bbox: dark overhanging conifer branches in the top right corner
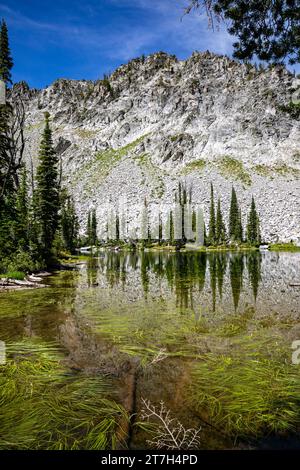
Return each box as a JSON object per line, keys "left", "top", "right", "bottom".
{"left": 186, "top": 0, "right": 300, "bottom": 64}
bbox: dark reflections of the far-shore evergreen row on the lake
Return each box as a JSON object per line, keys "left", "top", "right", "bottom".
{"left": 87, "top": 251, "right": 261, "bottom": 312}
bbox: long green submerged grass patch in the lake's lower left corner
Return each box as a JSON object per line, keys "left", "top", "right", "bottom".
{"left": 0, "top": 340, "right": 128, "bottom": 449}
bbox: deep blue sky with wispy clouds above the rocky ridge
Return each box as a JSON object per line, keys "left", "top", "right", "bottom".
{"left": 0, "top": 0, "right": 298, "bottom": 88}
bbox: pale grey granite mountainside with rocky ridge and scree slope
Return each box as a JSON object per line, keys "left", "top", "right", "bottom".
{"left": 13, "top": 52, "right": 300, "bottom": 242}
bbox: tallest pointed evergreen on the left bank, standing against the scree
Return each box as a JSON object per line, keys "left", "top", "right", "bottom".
{"left": 34, "top": 113, "right": 60, "bottom": 264}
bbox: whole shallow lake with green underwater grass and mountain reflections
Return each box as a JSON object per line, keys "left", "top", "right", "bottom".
{"left": 0, "top": 252, "right": 300, "bottom": 450}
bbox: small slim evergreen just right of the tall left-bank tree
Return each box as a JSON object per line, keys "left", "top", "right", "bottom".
{"left": 61, "top": 191, "right": 79, "bottom": 253}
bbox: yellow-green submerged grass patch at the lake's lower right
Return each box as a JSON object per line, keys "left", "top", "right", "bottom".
{"left": 189, "top": 342, "right": 300, "bottom": 438}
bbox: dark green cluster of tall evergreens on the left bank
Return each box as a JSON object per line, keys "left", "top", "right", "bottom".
{"left": 0, "top": 21, "right": 77, "bottom": 272}
